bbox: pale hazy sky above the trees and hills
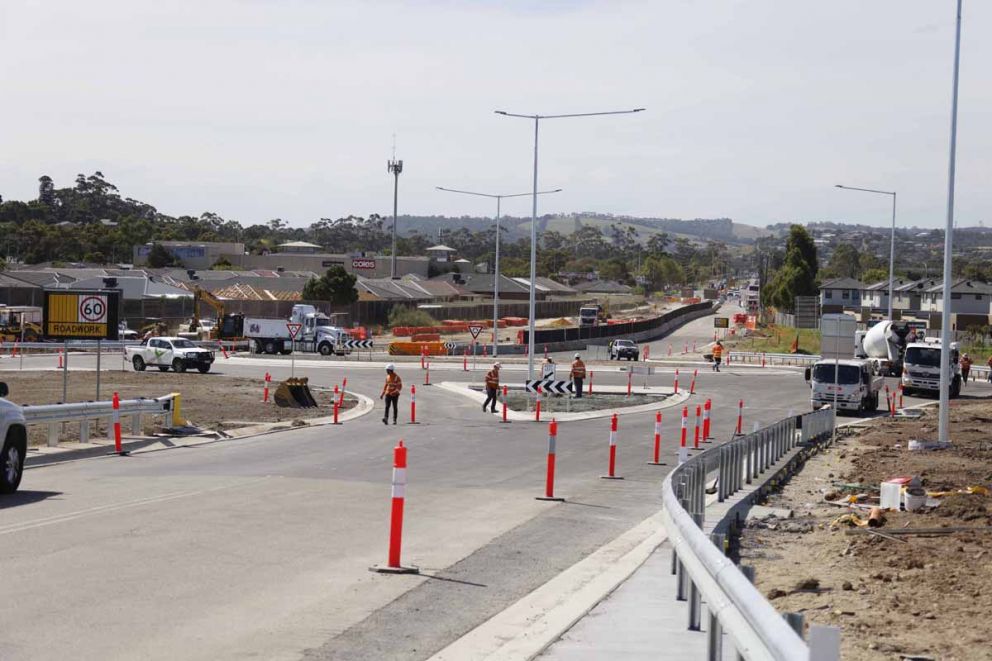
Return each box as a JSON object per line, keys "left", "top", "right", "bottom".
{"left": 0, "top": 0, "right": 992, "bottom": 226}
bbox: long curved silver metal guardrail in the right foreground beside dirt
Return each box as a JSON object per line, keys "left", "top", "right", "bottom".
{"left": 662, "top": 409, "right": 839, "bottom": 661}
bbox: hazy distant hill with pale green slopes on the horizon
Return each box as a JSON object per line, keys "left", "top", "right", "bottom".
{"left": 396, "top": 212, "right": 771, "bottom": 245}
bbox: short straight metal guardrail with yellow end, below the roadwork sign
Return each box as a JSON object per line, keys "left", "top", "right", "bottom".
{"left": 21, "top": 393, "right": 183, "bottom": 447}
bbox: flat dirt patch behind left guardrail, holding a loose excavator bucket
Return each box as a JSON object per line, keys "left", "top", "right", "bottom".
{"left": 0, "top": 370, "right": 357, "bottom": 445}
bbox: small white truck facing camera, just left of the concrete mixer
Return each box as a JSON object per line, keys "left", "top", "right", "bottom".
{"left": 806, "top": 359, "right": 885, "bottom": 413}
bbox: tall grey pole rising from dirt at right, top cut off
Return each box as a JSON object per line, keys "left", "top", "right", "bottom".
{"left": 937, "top": 0, "right": 961, "bottom": 443}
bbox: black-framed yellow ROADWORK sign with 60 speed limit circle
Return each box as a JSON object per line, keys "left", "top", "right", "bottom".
{"left": 42, "top": 289, "right": 120, "bottom": 340}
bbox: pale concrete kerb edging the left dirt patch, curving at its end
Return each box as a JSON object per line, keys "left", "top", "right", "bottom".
{"left": 24, "top": 392, "right": 375, "bottom": 469}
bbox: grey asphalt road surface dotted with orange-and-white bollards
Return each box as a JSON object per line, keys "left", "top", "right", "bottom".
{"left": 0, "top": 310, "right": 984, "bottom": 659}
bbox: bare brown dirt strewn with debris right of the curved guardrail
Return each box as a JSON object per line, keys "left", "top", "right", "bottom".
{"left": 740, "top": 402, "right": 992, "bottom": 661}
